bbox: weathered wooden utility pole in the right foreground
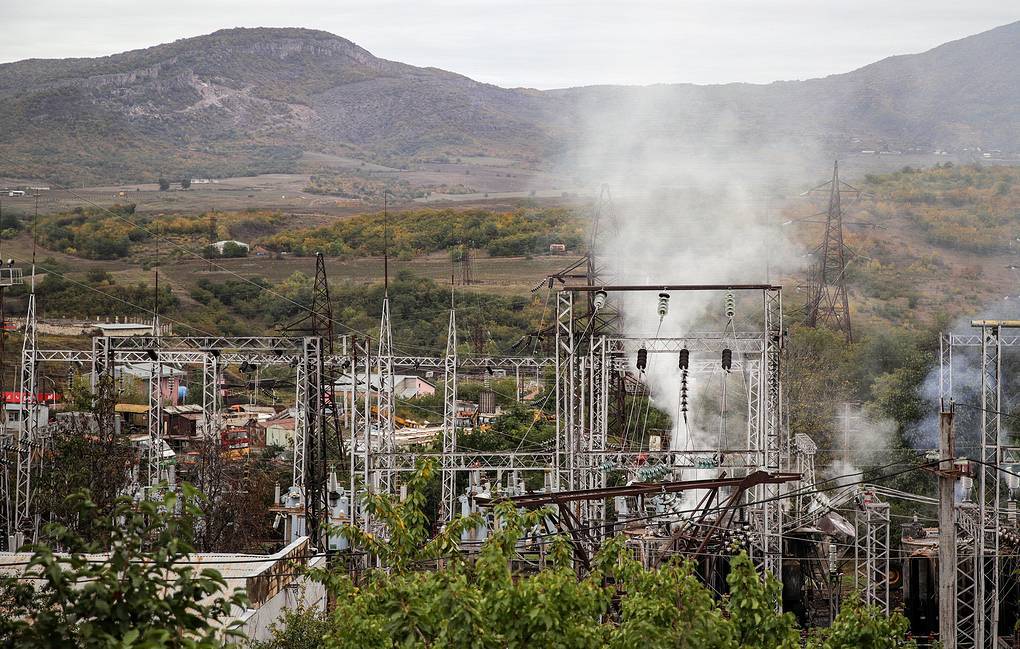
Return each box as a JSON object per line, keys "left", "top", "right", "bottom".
{"left": 938, "top": 403, "right": 957, "bottom": 649}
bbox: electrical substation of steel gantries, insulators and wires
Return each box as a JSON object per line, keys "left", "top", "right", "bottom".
{"left": 0, "top": 178, "right": 1020, "bottom": 649}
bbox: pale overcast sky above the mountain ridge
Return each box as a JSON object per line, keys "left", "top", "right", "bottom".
{"left": 0, "top": 0, "right": 1020, "bottom": 88}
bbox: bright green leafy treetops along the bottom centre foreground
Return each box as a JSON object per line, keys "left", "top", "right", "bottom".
{"left": 248, "top": 462, "right": 912, "bottom": 649}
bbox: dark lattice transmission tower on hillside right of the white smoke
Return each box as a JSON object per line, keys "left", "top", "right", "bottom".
{"left": 808, "top": 161, "right": 860, "bottom": 341}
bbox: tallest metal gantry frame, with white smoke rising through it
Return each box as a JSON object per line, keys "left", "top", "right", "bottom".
{"left": 555, "top": 285, "right": 786, "bottom": 576}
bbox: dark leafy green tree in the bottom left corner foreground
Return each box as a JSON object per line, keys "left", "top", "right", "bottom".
{"left": 0, "top": 484, "right": 246, "bottom": 649}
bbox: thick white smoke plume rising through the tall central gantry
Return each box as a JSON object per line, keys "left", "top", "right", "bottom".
{"left": 550, "top": 89, "right": 830, "bottom": 449}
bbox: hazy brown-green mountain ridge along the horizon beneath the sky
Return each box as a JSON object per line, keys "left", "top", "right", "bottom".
{"left": 0, "top": 21, "right": 1020, "bottom": 182}
